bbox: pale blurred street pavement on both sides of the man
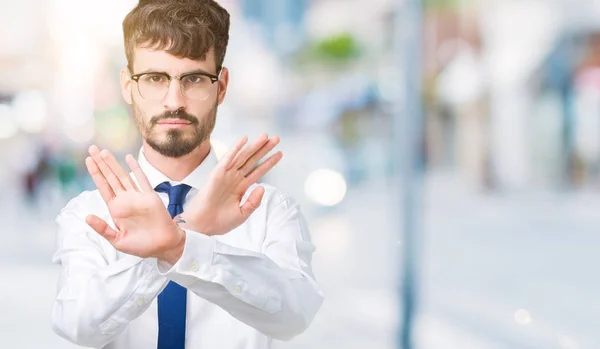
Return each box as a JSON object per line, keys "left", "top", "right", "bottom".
{"left": 0, "top": 168, "right": 600, "bottom": 349}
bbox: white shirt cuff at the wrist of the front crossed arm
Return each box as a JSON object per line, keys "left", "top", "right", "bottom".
{"left": 157, "top": 229, "right": 216, "bottom": 287}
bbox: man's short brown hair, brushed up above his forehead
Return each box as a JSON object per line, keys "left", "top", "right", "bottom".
{"left": 123, "top": 0, "right": 229, "bottom": 73}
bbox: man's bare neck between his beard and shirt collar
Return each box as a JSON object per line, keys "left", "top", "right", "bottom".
{"left": 143, "top": 139, "right": 210, "bottom": 182}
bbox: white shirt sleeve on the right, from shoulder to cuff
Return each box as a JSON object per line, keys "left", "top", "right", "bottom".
{"left": 158, "top": 189, "right": 323, "bottom": 340}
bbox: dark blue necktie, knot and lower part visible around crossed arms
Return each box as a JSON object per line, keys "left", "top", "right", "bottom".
{"left": 154, "top": 182, "right": 192, "bottom": 349}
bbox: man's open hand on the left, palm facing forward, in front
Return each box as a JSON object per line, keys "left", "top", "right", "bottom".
{"left": 85, "top": 146, "right": 185, "bottom": 264}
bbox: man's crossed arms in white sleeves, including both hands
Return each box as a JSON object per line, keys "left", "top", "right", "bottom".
{"left": 52, "top": 134, "right": 322, "bottom": 346}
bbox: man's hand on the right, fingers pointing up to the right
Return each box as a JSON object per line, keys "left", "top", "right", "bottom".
{"left": 178, "top": 134, "right": 283, "bottom": 235}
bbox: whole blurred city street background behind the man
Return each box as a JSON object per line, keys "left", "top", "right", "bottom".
{"left": 0, "top": 0, "right": 600, "bottom": 349}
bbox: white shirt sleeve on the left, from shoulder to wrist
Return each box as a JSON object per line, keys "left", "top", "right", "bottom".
{"left": 52, "top": 192, "right": 168, "bottom": 347}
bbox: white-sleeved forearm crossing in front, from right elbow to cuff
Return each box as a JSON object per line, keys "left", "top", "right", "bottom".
{"left": 159, "top": 231, "right": 323, "bottom": 340}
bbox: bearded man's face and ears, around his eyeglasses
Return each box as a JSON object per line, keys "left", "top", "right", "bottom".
{"left": 121, "top": 48, "right": 228, "bottom": 158}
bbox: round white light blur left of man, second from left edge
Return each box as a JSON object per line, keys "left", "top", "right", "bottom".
{"left": 12, "top": 91, "right": 48, "bottom": 133}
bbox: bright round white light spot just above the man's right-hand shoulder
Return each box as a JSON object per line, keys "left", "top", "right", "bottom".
{"left": 304, "top": 169, "right": 347, "bottom": 206}
